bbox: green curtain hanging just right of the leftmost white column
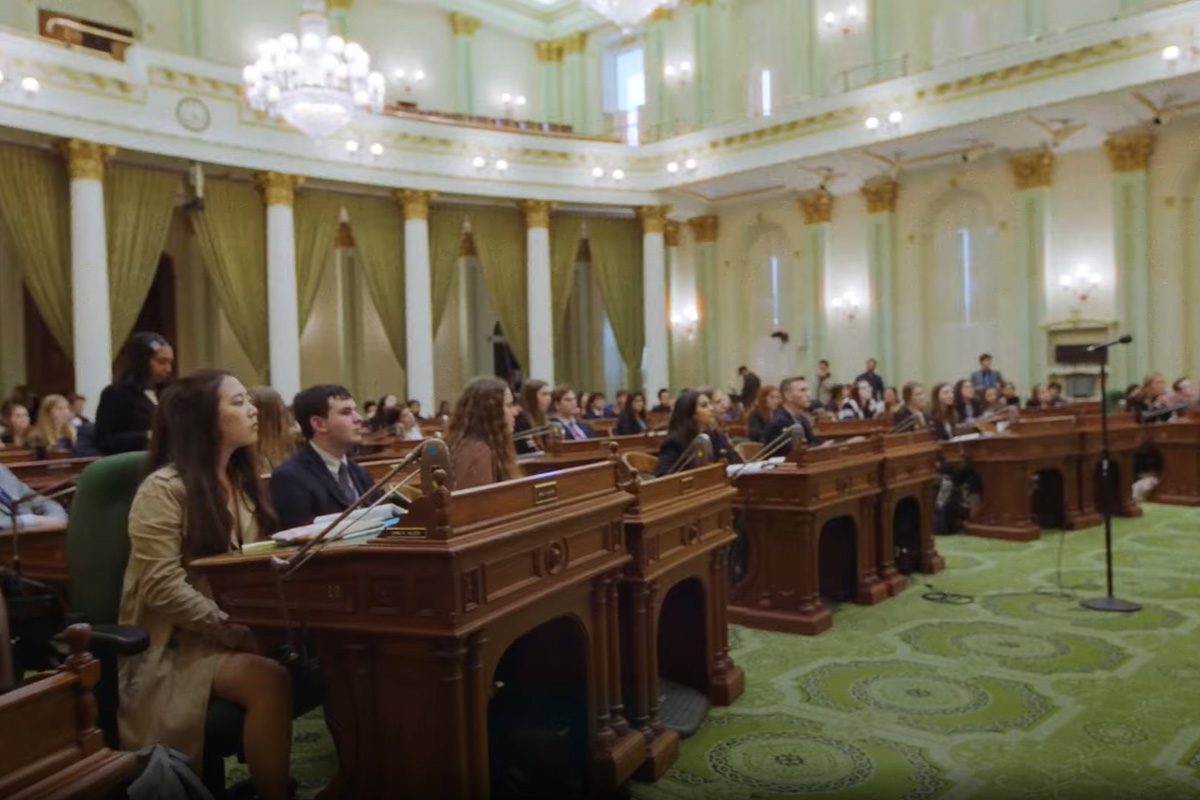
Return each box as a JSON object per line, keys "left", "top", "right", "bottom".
{"left": 104, "top": 164, "right": 181, "bottom": 353}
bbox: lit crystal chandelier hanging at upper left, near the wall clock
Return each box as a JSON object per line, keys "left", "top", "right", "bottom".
{"left": 241, "top": 0, "right": 384, "bottom": 138}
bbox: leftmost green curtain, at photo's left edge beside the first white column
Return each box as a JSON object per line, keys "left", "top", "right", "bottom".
{"left": 0, "top": 145, "right": 74, "bottom": 356}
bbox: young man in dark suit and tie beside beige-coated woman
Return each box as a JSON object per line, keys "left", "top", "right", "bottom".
{"left": 269, "top": 384, "right": 372, "bottom": 529}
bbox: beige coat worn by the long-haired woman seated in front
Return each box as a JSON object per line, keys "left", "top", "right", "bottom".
{"left": 118, "top": 467, "right": 258, "bottom": 772}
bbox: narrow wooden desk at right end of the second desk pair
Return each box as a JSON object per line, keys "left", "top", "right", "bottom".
{"left": 875, "top": 431, "right": 946, "bottom": 595}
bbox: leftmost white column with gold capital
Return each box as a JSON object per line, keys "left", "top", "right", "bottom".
{"left": 62, "top": 139, "right": 116, "bottom": 413}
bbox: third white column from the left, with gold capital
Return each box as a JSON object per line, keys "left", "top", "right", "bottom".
{"left": 396, "top": 190, "right": 437, "bottom": 414}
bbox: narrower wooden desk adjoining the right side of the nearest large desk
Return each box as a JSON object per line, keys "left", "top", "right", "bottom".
{"left": 620, "top": 462, "right": 745, "bottom": 781}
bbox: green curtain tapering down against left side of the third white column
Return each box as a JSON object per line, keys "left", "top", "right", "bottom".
{"left": 344, "top": 197, "right": 408, "bottom": 372}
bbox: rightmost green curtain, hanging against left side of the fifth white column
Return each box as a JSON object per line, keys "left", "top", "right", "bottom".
{"left": 588, "top": 217, "right": 646, "bottom": 386}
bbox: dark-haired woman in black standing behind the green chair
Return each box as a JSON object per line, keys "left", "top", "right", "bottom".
{"left": 94, "top": 332, "right": 175, "bottom": 456}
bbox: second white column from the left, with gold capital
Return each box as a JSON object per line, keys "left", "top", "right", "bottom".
{"left": 254, "top": 173, "right": 304, "bottom": 397}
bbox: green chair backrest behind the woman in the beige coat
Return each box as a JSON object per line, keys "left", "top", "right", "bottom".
{"left": 67, "top": 452, "right": 146, "bottom": 625}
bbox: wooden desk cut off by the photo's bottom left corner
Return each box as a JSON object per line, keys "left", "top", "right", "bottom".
{"left": 0, "top": 623, "right": 137, "bottom": 800}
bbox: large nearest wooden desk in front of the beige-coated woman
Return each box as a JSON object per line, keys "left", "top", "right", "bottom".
{"left": 192, "top": 461, "right": 647, "bottom": 800}
